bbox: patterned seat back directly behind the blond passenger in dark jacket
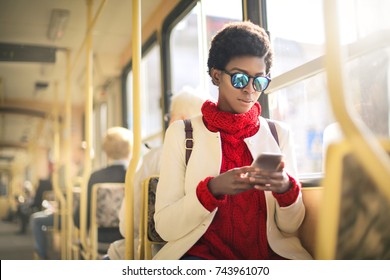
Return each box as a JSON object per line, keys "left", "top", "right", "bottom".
{"left": 88, "top": 183, "right": 125, "bottom": 260}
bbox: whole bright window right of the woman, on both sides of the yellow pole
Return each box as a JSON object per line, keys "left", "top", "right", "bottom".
{"left": 267, "top": 0, "right": 390, "bottom": 176}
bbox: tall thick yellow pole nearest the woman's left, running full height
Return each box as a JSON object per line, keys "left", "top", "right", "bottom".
{"left": 125, "top": 0, "right": 142, "bottom": 260}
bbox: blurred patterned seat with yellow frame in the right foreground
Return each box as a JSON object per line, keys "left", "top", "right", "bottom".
{"left": 317, "top": 139, "right": 390, "bottom": 260}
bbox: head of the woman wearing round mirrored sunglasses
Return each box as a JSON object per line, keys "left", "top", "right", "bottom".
{"left": 207, "top": 21, "right": 273, "bottom": 114}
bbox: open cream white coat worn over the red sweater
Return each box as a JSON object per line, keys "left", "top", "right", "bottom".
{"left": 154, "top": 116, "right": 311, "bottom": 260}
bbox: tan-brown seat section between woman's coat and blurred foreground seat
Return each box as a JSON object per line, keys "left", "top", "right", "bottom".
{"left": 298, "top": 187, "right": 323, "bottom": 258}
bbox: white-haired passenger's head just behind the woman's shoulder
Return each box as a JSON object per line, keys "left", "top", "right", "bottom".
{"left": 170, "top": 87, "right": 205, "bottom": 122}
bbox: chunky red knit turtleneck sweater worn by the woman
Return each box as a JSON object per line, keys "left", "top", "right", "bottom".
{"left": 186, "top": 101, "right": 300, "bottom": 260}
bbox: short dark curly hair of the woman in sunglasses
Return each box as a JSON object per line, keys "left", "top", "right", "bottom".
{"left": 207, "top": 21, "right": 273, "bottom": 77}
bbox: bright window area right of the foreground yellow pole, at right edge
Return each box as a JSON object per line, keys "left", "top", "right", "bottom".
{"left": 339, "top": 0, "right": 390, "bottom": 138}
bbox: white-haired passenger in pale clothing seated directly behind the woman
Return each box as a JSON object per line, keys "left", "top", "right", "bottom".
{"left": 106, "top": 87, "right": 205, "bottom": 260}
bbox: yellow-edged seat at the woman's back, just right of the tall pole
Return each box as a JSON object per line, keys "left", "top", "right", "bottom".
{"left": 140, "top": 176, "right": 165, "bottom": 260}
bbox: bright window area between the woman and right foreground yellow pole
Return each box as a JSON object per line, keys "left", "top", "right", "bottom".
{"left": 267, "top": 0, "right": 328, "bottom": 175}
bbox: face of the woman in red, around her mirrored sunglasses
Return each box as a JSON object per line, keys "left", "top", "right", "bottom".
{"left": 211, "top": 56, "right": 266, "bottom": 114}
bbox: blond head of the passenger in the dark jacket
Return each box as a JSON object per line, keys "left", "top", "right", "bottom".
{"left": 103, "top": 126, "right": 133, "bottom": 160}
